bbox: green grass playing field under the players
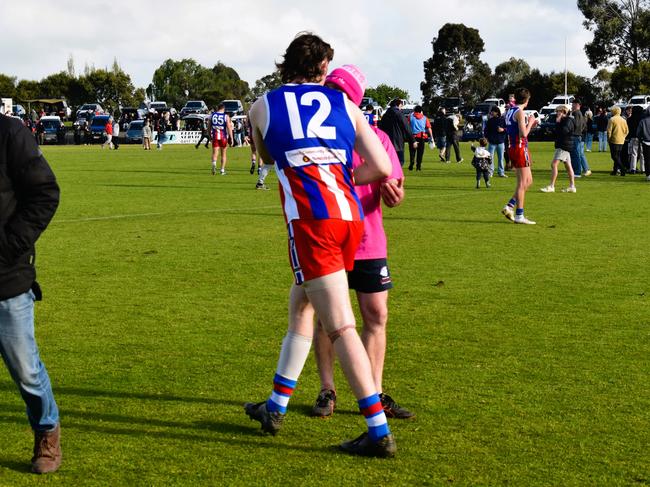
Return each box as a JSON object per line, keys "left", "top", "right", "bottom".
{"left": 0, "top": 143, "right": 650, "bottom": 486}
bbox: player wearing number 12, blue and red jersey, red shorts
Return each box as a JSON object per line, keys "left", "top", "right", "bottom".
{"left": 245, "top": 34, "right": 396, "bottom": 457}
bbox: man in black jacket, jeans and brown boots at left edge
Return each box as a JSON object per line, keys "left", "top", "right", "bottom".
{"left": 0, "top": 116, "right": 61, "bottom": 473}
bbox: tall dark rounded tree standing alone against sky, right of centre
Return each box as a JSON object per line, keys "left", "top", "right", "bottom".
{"left": 420, "top": 24, "right": 491, "bottom": 113}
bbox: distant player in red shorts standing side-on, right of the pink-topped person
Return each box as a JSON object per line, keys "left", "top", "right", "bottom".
{"left": 501, "top": 88, "right": 537, "bottom": 225}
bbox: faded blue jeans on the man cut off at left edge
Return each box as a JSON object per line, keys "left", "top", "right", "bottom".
{"left": 0, "top": 291, "right": 59, "bottom": 431}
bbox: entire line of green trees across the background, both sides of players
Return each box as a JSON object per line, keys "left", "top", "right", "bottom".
{"left": 0, "top": 0, "right": 650, "bottom": 113}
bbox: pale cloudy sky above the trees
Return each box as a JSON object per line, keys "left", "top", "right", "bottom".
{"left": 0, "top": 0, "right": 595, "bottom": 101}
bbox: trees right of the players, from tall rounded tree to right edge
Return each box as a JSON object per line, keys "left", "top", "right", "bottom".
{"left": 420, "top": 0, "right": 650, "bottom": 112}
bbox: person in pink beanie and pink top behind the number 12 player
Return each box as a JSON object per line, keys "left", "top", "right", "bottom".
{"left": 312, "top": 65, "right": 414, "bottom": 419}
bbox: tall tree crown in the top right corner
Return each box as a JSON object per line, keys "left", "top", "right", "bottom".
{"left": 578, "top": 0, "right": 650, "bottom": 69}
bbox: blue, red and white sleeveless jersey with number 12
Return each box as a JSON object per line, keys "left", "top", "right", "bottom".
{"left": 262, "top": 83, "right": 363, "bottom": 223}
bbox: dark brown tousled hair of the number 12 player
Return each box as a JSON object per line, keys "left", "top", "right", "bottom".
{"left": 275, "top": 32, "right": 334, "bottom": 83}
